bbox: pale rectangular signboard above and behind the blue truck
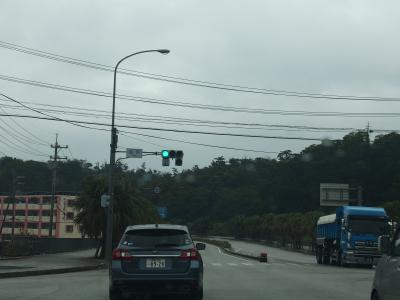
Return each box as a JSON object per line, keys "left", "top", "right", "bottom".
{"left": 319, "top": 183, "right": 350, "bottom": 206}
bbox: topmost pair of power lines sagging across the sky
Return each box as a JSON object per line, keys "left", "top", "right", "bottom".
{"left": 0, "top": 41, "right": 400, "bottom": 101}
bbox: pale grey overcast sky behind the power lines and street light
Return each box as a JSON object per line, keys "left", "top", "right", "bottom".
{"left": 0, "top": 0, "right": 400, "bottom": 171}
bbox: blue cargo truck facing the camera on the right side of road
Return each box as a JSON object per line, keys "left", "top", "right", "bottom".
{"left": 315, "top": 206, "right": 389, "bottom": 267}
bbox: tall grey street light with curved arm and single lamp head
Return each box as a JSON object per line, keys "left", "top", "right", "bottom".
{"left": 105, "top": 49, "right": 170, "bottom": 262}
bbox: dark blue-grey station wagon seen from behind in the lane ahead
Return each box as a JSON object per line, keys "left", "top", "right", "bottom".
{"left": 110, "top": 224, "right": 206, "bottom": 300}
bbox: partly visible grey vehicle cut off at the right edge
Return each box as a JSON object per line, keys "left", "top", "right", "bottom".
{"left": 371, "top": 228, "right": 400, "bottom": 300}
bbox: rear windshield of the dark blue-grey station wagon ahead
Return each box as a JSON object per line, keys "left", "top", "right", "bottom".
{"left": 121, "top": 229, "right": 192, "bottom": 248}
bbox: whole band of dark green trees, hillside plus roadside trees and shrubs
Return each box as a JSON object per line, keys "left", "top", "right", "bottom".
{"left": 0, "top": 131, "right": 400, "bottom": 251}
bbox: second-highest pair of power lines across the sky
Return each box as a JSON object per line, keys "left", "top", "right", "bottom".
{"left": 0, "top": 75, "right": 400, "bottom": 117}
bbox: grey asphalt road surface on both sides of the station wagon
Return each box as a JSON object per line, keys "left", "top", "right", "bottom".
{"left": 0, "top": 242, "right": 374, "bottom": 300}
